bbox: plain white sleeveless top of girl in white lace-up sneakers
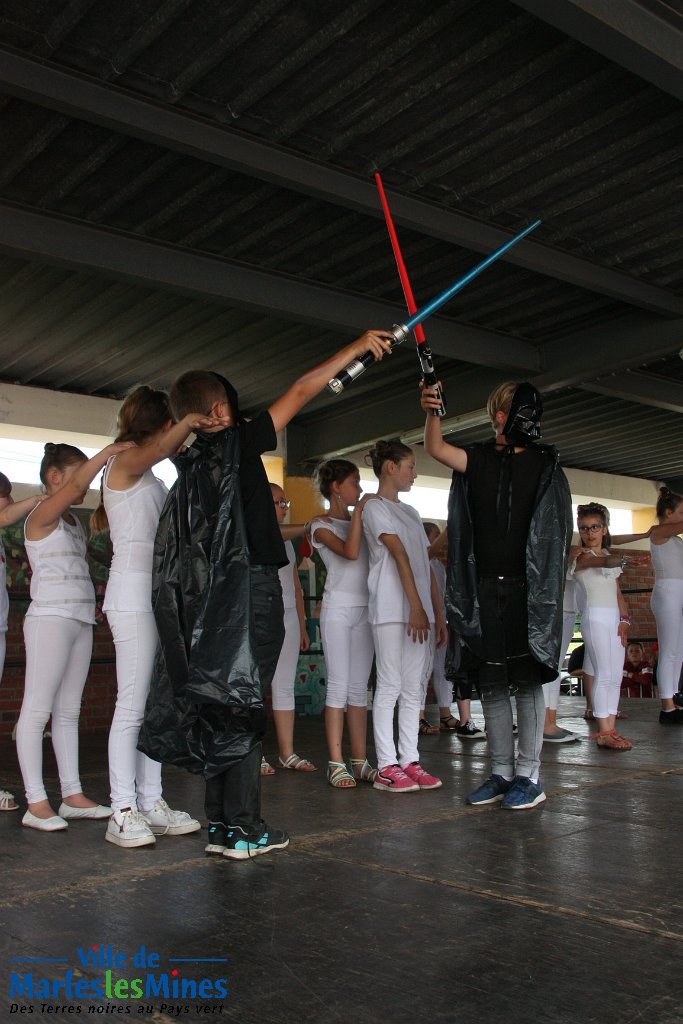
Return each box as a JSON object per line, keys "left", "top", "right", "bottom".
{"left": 102, "top": 456, "right": 168, "bottom": 611}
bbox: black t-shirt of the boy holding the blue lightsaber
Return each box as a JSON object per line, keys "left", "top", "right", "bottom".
{"left": 240, "top": 411, "right": 287, "bottom": 567}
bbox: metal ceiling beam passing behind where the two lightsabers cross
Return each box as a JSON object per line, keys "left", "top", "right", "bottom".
{"left": 0, "top": 203, "right": 540, "bottom": 373}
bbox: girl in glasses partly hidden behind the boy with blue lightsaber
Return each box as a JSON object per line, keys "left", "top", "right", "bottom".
{"left": 268, "top": 483, "right": 316, "bottom": 775}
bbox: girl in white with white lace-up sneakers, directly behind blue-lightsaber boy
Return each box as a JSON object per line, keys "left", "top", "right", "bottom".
{"left": 91, "top": 386, "right": 223, "bottom": 849}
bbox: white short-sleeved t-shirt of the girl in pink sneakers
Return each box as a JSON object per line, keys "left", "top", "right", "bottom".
{"left": 362, "top": 498, "right": 434, "bottom": 626}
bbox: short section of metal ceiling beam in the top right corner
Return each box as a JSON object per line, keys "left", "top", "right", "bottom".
{"left": 513, "top": 0, "right": 683, "bottom": 99}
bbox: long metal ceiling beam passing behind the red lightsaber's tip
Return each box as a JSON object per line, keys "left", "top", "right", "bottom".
{"left": 0, "top": 47, "right": 683, "bottom": 316}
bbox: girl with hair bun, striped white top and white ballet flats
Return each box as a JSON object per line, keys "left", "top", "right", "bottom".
{"left": 16, "top": 444, "right": 128, "bottom": 831}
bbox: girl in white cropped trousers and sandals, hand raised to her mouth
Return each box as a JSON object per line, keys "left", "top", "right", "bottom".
{"left": 310, "top": 459, "right": 377, "bottom": 790}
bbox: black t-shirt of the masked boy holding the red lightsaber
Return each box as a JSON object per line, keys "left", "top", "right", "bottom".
{"left": 465, "top": 444, "right": 548, "bottom": 577}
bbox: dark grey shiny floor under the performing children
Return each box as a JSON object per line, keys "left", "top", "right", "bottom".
{"left": 0, "top": 698, "right": 683, "bottom": 1024}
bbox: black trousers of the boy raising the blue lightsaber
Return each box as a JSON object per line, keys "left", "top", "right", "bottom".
{"left": 204, "top": 565, "right": 285, "bottom": 839}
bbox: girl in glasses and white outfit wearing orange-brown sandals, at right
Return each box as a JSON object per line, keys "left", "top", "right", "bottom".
{"left": 573, "top": 502, "right": 644, "bottom": 751}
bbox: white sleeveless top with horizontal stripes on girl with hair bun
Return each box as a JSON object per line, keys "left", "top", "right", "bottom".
{"left": 24, "top": 515, "right": 95, "bottom": 624}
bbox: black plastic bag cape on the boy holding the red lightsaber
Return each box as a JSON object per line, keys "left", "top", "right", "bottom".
{"left": 445, "top": 444, "right": 572, "bottom": 682}
